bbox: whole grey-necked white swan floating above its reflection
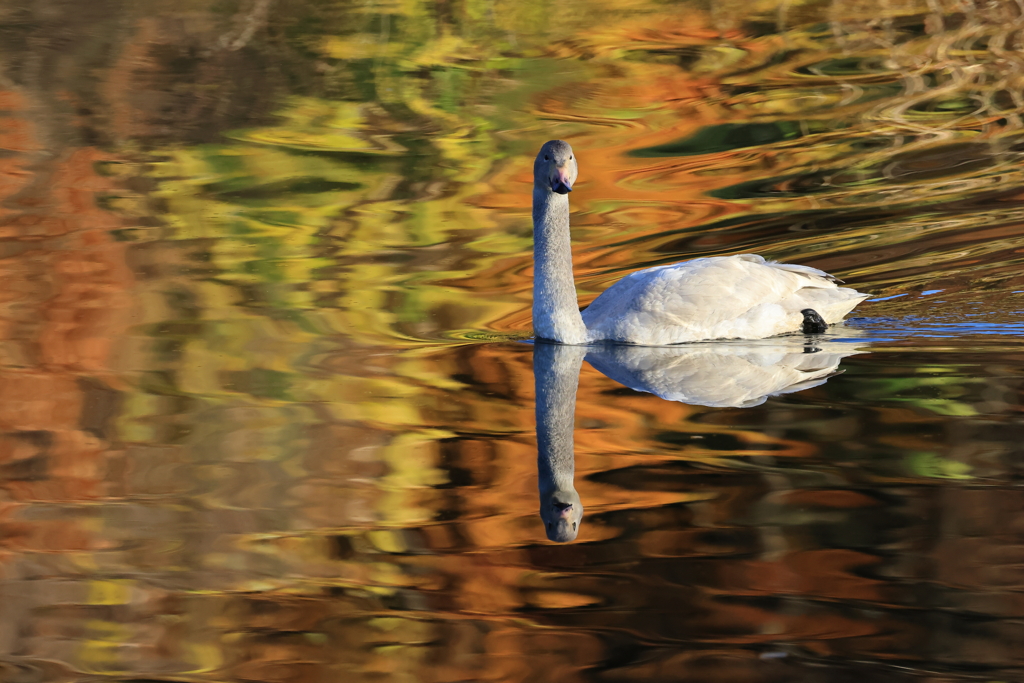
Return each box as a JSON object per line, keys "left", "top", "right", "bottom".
{"left": 534, "top": 140, "right": 870, "bottom": 346}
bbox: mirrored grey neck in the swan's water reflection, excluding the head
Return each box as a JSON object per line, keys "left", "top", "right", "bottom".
{"left": 534, "top": 343, "right": 587, "bottom": 493}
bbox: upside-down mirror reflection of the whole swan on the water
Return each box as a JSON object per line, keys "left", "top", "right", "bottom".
{"left": 534, "top": 336, "right": 859, "bottom": 543}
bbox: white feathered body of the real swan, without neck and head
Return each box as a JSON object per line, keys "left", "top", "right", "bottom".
{"left": 583, "top": 254, "right": 868, "bottom": 346}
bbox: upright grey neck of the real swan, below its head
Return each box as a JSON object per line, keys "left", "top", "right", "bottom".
{"left": 534, "top": 185, "right": 587, "bottom": 344}
